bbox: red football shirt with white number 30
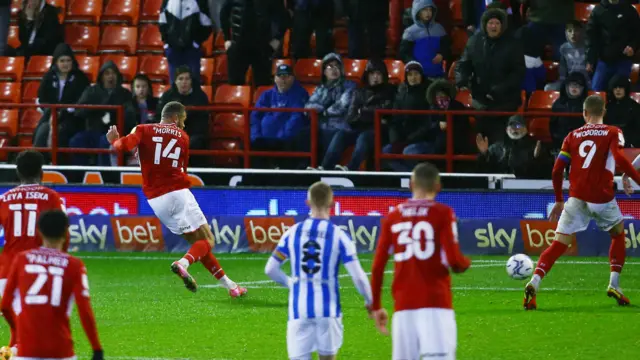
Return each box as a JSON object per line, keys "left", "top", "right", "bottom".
{"left": 371, "top": 200, "right": 471, "bottom": 311}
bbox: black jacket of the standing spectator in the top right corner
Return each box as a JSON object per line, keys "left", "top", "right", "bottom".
{"left": 586, "top": 0, "right": 640, "bottom": 66}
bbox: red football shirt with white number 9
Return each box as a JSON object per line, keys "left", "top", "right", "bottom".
{"left": 560, "top": 124, "right": 624, "bottom": 204}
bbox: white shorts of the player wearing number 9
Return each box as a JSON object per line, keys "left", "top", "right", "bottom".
{"left": 556, "top": 198, "right": 623, "bottom": 235}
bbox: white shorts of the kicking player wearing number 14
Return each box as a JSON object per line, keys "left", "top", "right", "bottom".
{"left": 147, "top": 189, "right": 207, "bottom": 235}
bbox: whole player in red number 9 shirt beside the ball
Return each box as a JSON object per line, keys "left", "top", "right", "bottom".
{"left": 524, "top": 95, "right": 640, "bottom": 310}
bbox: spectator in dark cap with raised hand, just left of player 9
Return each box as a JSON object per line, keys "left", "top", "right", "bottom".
{"left": 476, "top": 115, "right": 556, "bottom": 179}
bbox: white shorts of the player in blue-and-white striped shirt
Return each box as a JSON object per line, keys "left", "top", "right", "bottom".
{"left": 287, "top": 318, "right": 344, "bottom": 360}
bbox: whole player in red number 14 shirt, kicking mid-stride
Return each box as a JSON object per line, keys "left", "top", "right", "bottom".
{"left": 107, "top": 101, "right": 247, "bottom": 297}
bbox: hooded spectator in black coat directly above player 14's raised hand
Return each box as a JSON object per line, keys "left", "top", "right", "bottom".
{"left": 69, "top": 60, "right": 136, "bottom": 166}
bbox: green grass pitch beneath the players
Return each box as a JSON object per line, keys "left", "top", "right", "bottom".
{"left": 0, "top": 254, "right": 640, "bottom": 360}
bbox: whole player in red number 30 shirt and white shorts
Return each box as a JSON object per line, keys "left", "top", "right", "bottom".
{"left": 371, "top": 163, "right": 471, "bottom": 360}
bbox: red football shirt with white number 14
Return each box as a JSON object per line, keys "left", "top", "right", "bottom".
{"left": 113, "top": 124, "right": 191, "bottom": 199}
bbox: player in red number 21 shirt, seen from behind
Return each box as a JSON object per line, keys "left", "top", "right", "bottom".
{"left": 0, "top": 210, "right": 103, "bottom": 360}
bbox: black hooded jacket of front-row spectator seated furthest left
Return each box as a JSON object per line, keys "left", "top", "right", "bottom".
{"left": 38, "top": 43, "right": 91, "bottom": 130}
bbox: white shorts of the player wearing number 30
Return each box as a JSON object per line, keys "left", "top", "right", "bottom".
{"left": 391, "top": 309, "right": 458, "bottom": 360}
